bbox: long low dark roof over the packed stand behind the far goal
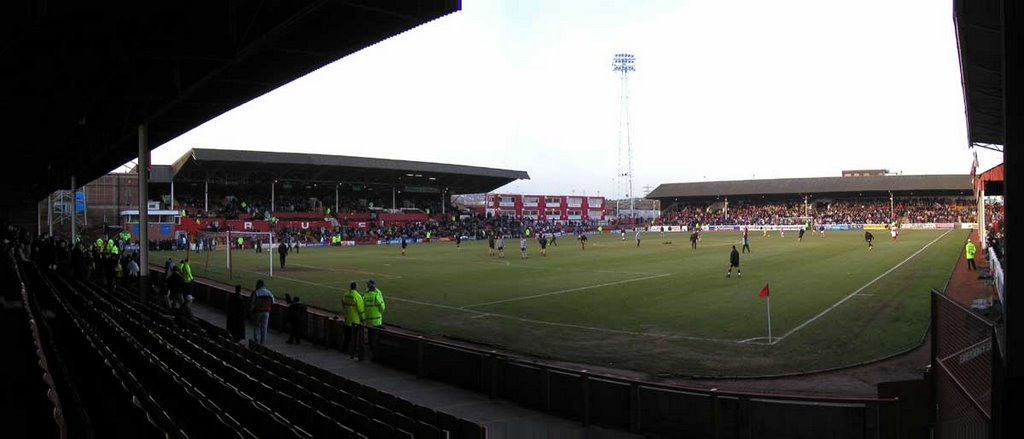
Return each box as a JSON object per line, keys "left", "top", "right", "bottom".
{"left": 646, "top": 174, "right": 973, "bottom": 202}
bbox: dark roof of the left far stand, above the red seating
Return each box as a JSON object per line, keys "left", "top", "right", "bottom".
{"left": 153, "top": 148, "right": 529, "bottom": 193}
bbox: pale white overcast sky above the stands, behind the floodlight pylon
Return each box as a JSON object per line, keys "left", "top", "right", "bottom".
{"left": 140, "top": 0, "right": 1001, "bottom": 197}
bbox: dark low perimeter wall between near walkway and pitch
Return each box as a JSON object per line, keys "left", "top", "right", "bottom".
{"left": 165, "top": 266, "right": 900, "bottom": 438}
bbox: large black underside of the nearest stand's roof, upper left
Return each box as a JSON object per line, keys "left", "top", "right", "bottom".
{"left": 0, "top": 0, "right": 462, "bottom": 211}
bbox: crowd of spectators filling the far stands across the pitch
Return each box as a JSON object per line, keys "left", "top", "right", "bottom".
{"left": 97, "top": 191, "right": 998, "bottom": 250}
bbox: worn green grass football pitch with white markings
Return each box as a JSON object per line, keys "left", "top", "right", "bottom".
{"left": 151, "top": 229, "right": 968, "bottom": 377}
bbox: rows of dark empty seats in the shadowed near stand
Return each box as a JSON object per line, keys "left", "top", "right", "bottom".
{"left": 14, "top": 254, "right": 484, "bottom": 439}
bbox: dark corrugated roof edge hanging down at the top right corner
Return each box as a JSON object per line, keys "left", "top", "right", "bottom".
{"left": 953, "top": 0, "right": 1006, "bottom": 146}
